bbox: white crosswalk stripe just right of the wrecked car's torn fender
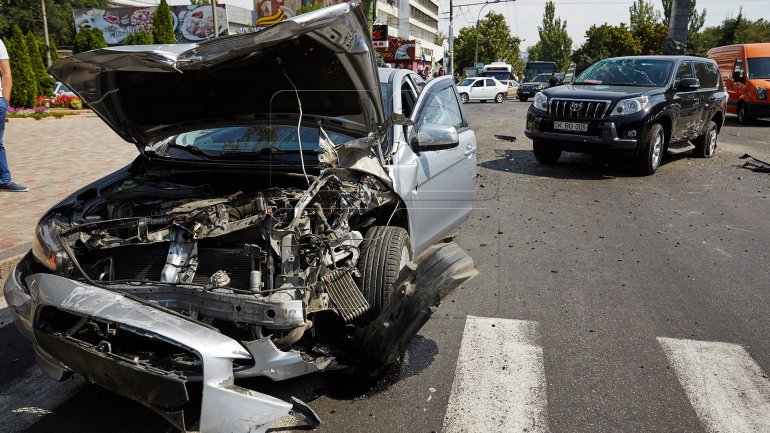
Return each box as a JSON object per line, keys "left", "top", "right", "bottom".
{"left": 444, "top": 316, "right": 548, "bottom": 433}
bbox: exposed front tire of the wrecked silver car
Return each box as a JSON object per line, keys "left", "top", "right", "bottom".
{"left": 356, "top": 226, "right": 412, "bottom": 324}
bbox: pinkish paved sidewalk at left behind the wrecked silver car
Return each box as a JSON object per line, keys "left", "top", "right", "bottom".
{"left": 0, "top": 113, "right": 139, "bottom": 281}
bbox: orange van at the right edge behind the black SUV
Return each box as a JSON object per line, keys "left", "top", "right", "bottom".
{"left": 707, "top": 42, "right": 770, "bottom": 124}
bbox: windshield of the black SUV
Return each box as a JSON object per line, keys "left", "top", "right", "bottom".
{"left": 573, "top": 59, "right": 674, "bottom": 87}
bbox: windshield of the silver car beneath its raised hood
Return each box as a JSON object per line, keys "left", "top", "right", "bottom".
{"left": 148, "top": 125, "right": 353, "bottom": 159}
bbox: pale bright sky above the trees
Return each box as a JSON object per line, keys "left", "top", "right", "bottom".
{"left": 439, "top": 0, "right": 770, "bottom": 50}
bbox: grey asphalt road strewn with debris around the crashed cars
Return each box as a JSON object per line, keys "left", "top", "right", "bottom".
{"left": 0, "top": 101, "right": 770, "bottom": 433}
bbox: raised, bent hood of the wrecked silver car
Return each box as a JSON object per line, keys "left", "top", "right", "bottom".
{"left": 50, "top": 3, "right": 384, "bottom": 149}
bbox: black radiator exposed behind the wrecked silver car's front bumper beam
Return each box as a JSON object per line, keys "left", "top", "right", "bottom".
{"left": 80, "top": 242, "right": 251, "bottom": 289}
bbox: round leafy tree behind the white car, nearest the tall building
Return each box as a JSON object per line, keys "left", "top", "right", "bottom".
{"left": 453, "top": 12, "right": 521, "bottom": 72}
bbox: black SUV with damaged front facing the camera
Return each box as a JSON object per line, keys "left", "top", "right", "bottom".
{"left": 525, "top": 56, "right": 727, "bottom": 175}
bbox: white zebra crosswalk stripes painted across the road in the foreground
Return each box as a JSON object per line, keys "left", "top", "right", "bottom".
{"left": 0, "top": 310, "right": 770, "bottom": 433}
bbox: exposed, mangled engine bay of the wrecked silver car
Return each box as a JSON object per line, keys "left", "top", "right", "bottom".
{"left": 51, "top": 169, "right": 397, "bottom": 368}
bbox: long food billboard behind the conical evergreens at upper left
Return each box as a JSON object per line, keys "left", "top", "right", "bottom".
{"left": 73, "top": 5, "right": 227, "bottom": 45}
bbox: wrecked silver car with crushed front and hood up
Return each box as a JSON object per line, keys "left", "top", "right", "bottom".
{"left": 4, "top": 4, "right": 476, "bottom": 433}
